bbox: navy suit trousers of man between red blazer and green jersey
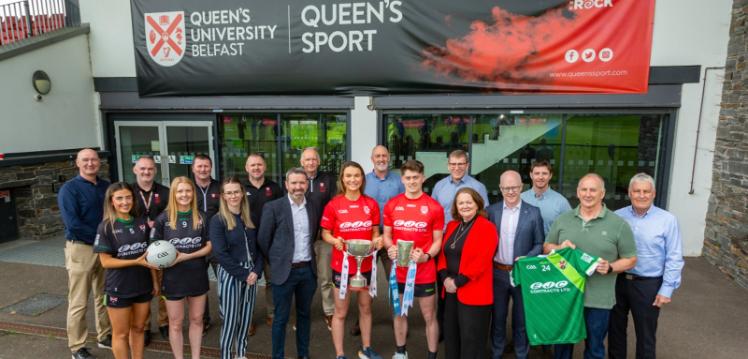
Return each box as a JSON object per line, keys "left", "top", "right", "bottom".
{"left": 491, "top": 269, "right": 530, "bottom": 359}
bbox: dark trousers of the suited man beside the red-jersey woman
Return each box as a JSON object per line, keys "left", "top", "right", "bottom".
{"left": 272, "top": 266, "right": 317, "bottom": 359}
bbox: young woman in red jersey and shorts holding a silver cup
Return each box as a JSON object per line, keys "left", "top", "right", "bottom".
{"left": 320, "top": 161, "right": 382, "bottom": 359}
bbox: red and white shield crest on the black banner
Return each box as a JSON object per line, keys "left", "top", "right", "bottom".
{"left": 145, "top": 11, "right": 187, "bottom": 67}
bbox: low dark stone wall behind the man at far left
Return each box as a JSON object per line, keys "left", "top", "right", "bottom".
{"left": 0, "top": 159, "right": 109, "bottom": 239}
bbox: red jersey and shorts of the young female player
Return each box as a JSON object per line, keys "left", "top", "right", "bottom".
{"left": 319, "top": 194, "right": 379, "bottom": 274}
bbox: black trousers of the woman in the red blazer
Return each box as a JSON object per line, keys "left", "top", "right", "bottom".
{"left": 444, "top": 293, "right": 492, "bottom": 359}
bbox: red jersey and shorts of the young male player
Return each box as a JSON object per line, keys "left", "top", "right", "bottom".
{"left": 384, "top": 193, "right": 444, "bottom": 284}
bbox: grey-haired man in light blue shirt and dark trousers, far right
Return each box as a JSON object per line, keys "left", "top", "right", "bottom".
{"left": 608, "top": 173, "right": 683, "bottom": 359}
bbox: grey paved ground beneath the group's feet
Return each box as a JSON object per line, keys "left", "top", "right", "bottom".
{"left": 0, "top": 238, "right": 748, "bottom": 359}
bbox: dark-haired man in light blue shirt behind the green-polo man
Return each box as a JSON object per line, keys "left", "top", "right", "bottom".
{"left": 522, "top": 160, "right": 571, "bottom": 235}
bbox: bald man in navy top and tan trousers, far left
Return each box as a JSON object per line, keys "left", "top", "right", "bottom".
{"left": 57, "top": 148, "right": 112, "bottom": 359}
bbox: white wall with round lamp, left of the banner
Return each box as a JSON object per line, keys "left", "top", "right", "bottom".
{"left": 0, "top": 35, "right": 101, "bottom": 153}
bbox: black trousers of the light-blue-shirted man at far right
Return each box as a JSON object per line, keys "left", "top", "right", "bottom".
{"left": 608, "top": 273, "right": 662, "bottom": 359}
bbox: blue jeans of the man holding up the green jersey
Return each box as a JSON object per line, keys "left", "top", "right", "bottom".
{"left": 553, "top": 307, "right": 610, "bottom": 359}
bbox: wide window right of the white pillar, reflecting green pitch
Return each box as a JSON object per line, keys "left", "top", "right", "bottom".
{"left": 383, "top": 111, "right": 669, "bottom": 208}
